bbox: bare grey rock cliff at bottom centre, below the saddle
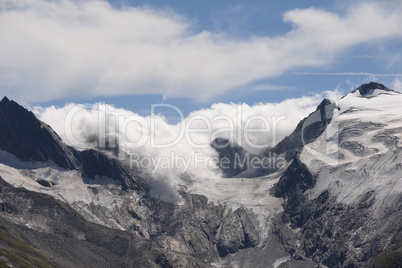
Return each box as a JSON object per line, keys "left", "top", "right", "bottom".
{"left": 124, "top": 188, "right": 259, "bottom": 262}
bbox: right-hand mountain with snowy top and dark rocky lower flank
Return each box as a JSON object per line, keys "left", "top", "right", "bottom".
{"left": 274, "top": 82, "right": 402, "bottom": 267}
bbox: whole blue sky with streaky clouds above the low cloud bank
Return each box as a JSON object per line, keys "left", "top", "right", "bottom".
{"left": 0, "top": 0, "right": 402, "bottom": 117}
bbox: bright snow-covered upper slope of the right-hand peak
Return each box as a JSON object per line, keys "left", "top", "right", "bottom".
{"left": 301, "top": 82, "right": 402, "bottom": 209}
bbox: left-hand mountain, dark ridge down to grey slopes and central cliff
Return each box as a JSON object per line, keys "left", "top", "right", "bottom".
{"left": 0, "top": 98, "right": 258, "bottom": 267}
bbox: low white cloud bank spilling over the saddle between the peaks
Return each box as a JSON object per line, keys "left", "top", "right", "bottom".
{"left": 33, "top": 91, "right": 340, "bottom": 199}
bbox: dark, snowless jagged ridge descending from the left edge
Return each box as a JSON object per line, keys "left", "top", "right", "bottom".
{"left": 0, "top": 97, "right": 147, "bottom": 190}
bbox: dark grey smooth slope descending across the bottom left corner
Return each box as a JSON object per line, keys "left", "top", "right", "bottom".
{"left": 0, "top": 178, "right": 158, "bottom": 267}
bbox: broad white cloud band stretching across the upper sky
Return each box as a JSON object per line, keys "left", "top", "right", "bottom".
{"left": 0, "top": 0, "right": 402, "bottom": 101}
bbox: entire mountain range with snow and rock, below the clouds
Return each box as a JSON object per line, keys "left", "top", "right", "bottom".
{"left": 0, "top": 82, "right": 402, "bottom": 268}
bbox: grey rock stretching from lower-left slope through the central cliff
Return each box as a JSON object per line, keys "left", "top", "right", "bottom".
{"left": 0, "top": 172, "right": 258, "bottom": 267}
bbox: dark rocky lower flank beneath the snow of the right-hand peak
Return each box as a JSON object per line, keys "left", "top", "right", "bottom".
{"left": 274, "top": 175, "right": 402, "bottom": 268}
